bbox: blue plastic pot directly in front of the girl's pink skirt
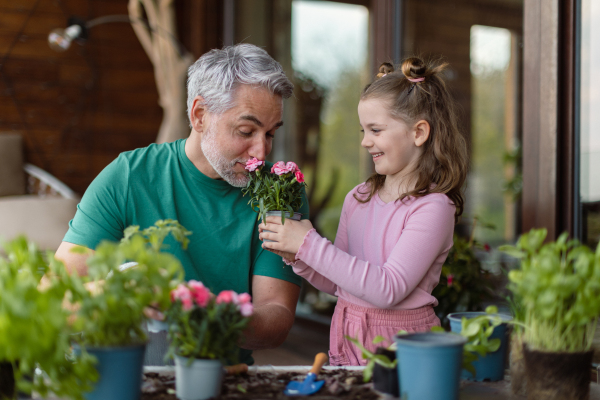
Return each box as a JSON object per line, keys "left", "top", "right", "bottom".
{"left": 395, "top": 332, "right": 467, "bottom": 400}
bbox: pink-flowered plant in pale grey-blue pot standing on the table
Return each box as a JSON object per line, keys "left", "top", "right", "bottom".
{"left": 166, "top": 280, "right": 253, "bottom": 400}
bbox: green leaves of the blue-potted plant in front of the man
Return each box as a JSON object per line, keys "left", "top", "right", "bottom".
{"left": 72, "top": 220, "right": 191, "bottom": 346}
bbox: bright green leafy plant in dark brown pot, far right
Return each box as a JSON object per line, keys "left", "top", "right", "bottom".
{"left": 501, "top": 229, "right": 600, "bottom": 399}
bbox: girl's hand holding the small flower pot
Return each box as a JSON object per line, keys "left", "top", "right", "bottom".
{"left": 258, "top": 217, "right": 313, "bottom": 253}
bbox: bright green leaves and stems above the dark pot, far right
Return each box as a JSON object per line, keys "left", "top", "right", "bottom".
{"left": 501, "top": 229, "right": 600, "bottom": 352}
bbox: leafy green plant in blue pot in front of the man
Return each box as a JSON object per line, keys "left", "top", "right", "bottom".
{"left": 71, "top": 220, "right": 190, "bottom": 400}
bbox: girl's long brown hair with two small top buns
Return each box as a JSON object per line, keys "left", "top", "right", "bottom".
{"left": 354, "top": 57, "right": 469, "bottom": 222}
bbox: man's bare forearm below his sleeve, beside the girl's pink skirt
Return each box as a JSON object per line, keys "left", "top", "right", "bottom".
{"left": 241, "top": 275, "right": 300, "bottom": 350}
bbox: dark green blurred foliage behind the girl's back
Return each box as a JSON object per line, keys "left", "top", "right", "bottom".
{"left": 432, "top": 231, "right": 493, "bottom": 322}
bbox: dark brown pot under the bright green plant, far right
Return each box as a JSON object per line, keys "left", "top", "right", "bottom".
{"left": 523, "top": 345, "right": 594, "bottom": 400}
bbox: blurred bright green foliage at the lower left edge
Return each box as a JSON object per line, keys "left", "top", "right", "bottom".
{"left": 0, "top": 237, "right": 97, "bottom": 399}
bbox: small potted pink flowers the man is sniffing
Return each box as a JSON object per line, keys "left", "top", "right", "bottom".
{"left": 242, "top": 158, "right": 306, "bottom": 223}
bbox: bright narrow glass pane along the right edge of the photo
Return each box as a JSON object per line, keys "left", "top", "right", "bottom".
{"left": 579, "top": 0, "right": 600, "bottom": 248}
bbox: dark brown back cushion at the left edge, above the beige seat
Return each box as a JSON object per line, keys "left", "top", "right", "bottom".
{"left": 0, "top": 133, "right": 26, "bottom": 196}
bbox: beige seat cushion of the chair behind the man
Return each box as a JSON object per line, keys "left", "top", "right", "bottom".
{"left": 0, "top": 195, "right": 79, "bottom": 251}
